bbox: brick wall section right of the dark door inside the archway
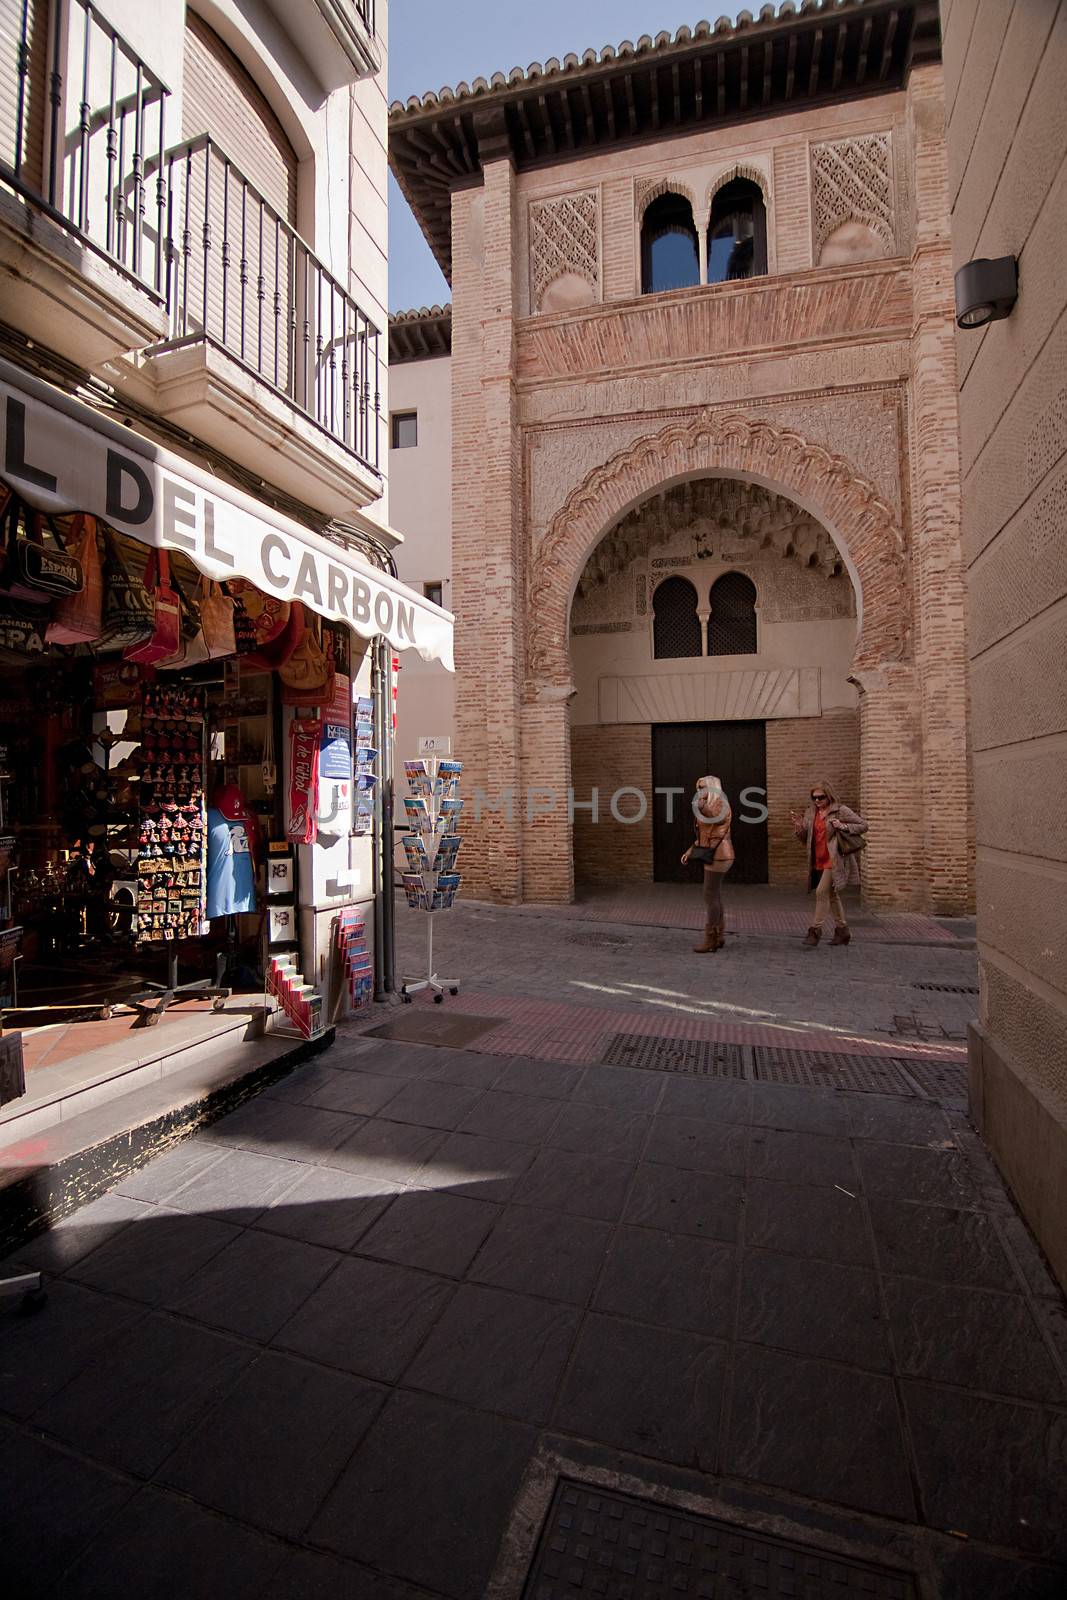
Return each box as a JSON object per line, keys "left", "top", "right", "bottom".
{"left": 766, "top": 709, "right": 859, "bottom": 888}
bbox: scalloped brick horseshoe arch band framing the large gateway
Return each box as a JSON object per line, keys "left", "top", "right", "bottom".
{"left": 526, "top": 411, "right": 910, "bottom": 699}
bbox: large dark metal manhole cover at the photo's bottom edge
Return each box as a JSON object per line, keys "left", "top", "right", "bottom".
{"left": 523, "top": 1478, "right": 918, "bottom": 1600}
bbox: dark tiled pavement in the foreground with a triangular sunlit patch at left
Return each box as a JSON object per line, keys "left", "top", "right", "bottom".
{"left": 0, "top": 1030, "right": 1067, "bottom": 1600}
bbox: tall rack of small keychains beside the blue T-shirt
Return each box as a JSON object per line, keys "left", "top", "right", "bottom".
{"left": 138, "top": 683, "right": 208, "bottom": 944}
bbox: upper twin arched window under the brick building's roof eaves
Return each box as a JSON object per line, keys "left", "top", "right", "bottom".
{"left": 641, "top": 178, "right": 766, "bottom": 294}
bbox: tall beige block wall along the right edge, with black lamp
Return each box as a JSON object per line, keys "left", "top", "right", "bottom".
{"left": 942, "top": 0, "right": 1067, "bottom": 1283}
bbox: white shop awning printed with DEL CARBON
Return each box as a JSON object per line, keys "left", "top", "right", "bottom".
{"left": 0, "top": 360, "right": 453, "bottom": 672}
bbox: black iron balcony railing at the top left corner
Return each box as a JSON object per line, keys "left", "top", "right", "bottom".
{"left": 0, "top": 0, "right": 170, "bottom": 296}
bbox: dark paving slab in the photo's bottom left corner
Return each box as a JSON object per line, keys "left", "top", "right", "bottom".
{"left": 0, "top": 1422, "right": 136, "bottom": 1600}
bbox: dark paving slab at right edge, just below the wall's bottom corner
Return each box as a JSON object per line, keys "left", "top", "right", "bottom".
{"left": 885, "top": 1277, "right": 1067, "bottom": 1401}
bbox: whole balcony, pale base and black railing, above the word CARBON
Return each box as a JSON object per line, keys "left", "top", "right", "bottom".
{"left": 139, "top": 134, "right": 382, "bottom": 515}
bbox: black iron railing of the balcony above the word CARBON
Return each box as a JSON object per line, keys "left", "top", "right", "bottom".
{"left": 154, "top": 134, "right": 381, "bottom": 470}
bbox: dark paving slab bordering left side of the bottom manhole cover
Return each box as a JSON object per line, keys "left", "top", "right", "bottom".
{"left": 310, "top": 1394, "right": 536, "bottom": 1600}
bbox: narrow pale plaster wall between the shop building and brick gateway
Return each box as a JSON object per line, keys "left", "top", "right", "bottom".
{"left": 389, "top": 355, "right": 464, "bottom": 774}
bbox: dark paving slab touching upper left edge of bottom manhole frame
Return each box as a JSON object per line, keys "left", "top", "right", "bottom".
{"left": 553, "top": 1315, "right": 726, "bottom": 1472}
